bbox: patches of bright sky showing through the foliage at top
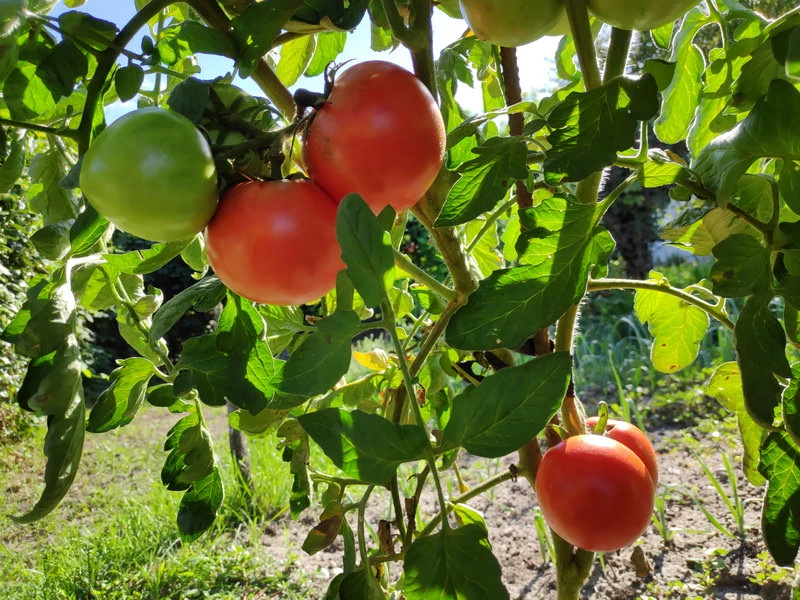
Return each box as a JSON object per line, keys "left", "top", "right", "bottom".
{"left": 52, "top": 0, "right": 558, "bottom": 121}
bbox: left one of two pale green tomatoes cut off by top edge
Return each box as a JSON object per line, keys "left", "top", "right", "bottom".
{"left": 459, "top": 0, "right": 564, "bottom": 48}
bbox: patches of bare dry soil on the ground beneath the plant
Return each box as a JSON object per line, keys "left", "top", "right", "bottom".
{"left": 4, "top": 409, "right": 800, "bottom": 600}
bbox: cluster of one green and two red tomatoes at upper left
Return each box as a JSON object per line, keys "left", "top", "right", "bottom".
{"left": 80, "top": 61, "right": 445, "bottom": 305}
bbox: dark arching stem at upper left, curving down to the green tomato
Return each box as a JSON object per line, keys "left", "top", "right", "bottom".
{"left": 75, "top": 0, "right": 176, "bottom": 155}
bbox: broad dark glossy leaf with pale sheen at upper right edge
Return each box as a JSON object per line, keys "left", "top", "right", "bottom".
{"left": 692, "top": 80, "right": 800, "bottom": 206}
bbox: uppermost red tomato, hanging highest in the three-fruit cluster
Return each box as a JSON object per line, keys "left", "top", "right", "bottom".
{"left": 303, "top": 60, "right": 445, "bottom": 214}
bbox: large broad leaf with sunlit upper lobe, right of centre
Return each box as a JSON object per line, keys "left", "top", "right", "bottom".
{"left": 446, "top": 196, "right": 614, "bottom": 350}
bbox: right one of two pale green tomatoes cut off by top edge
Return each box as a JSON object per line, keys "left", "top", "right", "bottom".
{"left": 587, "top": 0, "right": 698, "bottom": 31}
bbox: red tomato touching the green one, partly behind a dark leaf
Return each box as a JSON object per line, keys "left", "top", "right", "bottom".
{"left": 206, "top": 180, "right": 344, "bottom": 306}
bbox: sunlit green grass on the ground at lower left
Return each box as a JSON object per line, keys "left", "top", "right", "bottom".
{"left": 0, "top": 409, "right": 308, "bottom": 600}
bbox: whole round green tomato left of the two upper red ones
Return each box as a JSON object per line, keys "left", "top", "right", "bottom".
{"left": 80, "top": 108, "right": 217, "bottom": 242}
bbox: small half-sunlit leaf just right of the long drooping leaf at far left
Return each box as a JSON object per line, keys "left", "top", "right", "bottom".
{"left": 86, "top": 357, "right": 155, "bottom": 433}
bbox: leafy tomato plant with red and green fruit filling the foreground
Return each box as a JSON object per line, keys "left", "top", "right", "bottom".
{"left": 0, "top": 0, "right": 800, "bottom": 600}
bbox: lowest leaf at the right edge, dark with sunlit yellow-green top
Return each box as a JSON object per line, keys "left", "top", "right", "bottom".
{"left": 758, "top": 431, "right": 800, "bottom": 566}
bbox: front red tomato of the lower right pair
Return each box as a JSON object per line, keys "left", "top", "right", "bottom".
{"left": 536, "top": 435, "right": 653, "bottom": 552}
